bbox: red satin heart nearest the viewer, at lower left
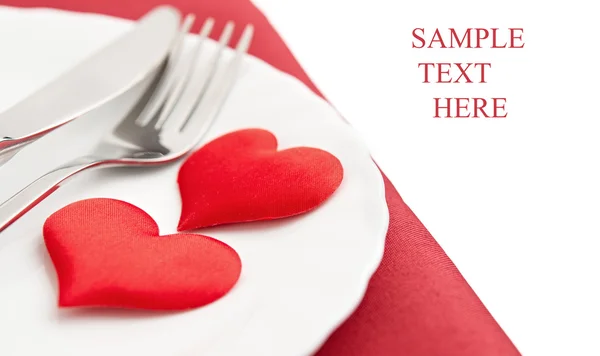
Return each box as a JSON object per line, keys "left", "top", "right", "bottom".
{"left": 44, "top": 199, "right": 241, "bottom": 310}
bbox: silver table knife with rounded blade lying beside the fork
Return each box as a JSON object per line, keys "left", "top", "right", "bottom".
{"left": 0, "top": 6, "right": 181, "bottom": 166}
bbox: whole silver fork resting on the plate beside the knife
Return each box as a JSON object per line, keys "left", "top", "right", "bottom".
{"left": 0, "top": 15, "right": 254, "bottom": 232}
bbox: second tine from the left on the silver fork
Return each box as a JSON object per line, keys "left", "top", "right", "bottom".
{"left": 155, "top": 18, "right": 215, "bottom": 129}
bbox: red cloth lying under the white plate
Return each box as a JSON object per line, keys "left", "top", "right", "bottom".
{"left": 0, "top": 0, "right": 519, "bottom": 356}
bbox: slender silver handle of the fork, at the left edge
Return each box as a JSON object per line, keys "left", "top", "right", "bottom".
{"left": 0, "top": 157, "right": 100, "bottom": 232}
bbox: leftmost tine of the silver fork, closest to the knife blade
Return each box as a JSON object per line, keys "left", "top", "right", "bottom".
{"left": 135, "top": 14, "right": 196, "bottom": 126}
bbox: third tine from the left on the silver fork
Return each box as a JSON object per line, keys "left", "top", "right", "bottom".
{"left": 164, "top": 21, "right": 235, "bottom": 132}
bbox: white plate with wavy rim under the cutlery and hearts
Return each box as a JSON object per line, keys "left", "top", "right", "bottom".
{"left": 0, "top": 8, "right": 388, "bottom": 356}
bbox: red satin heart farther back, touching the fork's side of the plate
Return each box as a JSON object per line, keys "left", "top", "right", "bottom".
{"left": 178, "top": 129, "right": 343, "bottom": 231}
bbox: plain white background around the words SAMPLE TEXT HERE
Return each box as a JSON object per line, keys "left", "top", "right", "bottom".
{"left": 255, "top": 0, "right": 600, "bottom": 356}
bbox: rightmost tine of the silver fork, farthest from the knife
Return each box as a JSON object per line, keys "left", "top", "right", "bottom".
{"left": 181, "top": 25, "right": 254, "bottom": 140}
